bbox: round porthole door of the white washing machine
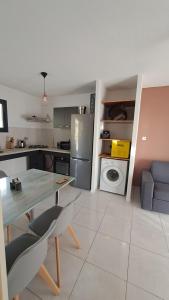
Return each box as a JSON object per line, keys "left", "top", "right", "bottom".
{"left": 102, "top": 166, "right": 123, "bottom": 186}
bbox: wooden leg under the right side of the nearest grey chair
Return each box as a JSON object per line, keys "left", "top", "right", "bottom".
{"left": 38, "top": 265, "right": 60, "bottom": 295}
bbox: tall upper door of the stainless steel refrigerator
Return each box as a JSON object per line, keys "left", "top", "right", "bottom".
{"left": 71, "top": 115, "right": 94, "bottom": 160}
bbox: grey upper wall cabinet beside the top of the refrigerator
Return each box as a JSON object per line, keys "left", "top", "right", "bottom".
{"left": 53, "top": 106, "right": 78, "bottom": 128}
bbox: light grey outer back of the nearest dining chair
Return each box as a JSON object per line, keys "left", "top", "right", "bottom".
{"left": 8, "top": 220, "right": 56, "bottom": 297}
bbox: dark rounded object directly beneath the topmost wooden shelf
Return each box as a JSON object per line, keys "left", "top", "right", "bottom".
{"left": 108, "top": 104, "right": 127, "bottom": 121}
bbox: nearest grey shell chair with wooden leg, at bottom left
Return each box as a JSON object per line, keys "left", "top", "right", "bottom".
{"left": 5, "top": 221, "right": 60, "bottom": 300}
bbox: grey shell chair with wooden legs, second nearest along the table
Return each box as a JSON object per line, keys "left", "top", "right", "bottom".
{"left": 29, "top": 197, "right": 80, "bottom": 288}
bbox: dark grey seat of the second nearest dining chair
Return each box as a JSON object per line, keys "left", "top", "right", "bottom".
{"left": 29, "top": 205, "right": 63, "bottom": 236}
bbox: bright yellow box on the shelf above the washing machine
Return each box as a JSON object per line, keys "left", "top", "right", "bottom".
{"left": 111, "top": 140, "right": 130, "bottom": 158}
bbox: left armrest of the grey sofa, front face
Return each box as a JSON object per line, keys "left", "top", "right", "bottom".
{"left": 140, "top": 170, "right": 154, "bottom": 210}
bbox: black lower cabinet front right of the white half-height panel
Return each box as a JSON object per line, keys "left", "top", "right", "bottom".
{"left": 28, "top": 151, "right": 45, "bottom": 170}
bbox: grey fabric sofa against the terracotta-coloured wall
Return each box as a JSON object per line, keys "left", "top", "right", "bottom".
{"left": 141, "top": 161, "right": 169, "bottom": 214}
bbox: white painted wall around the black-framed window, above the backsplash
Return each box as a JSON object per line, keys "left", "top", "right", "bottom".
{"left": 0, "top": 85, "right": 41, "bottom": 128}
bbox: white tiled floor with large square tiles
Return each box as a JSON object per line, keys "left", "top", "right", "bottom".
{"left": 9, "top": 187, "right": 169, "bottom": 300}
